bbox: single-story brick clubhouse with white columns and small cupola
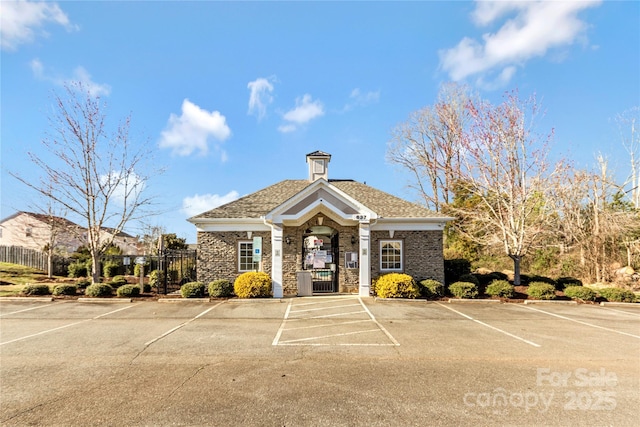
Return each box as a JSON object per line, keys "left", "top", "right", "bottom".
{"left": 189, "top": 151, "right": 453, "bottom": 298}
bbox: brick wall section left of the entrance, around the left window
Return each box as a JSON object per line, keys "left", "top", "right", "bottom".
{"left": 197, "top": 231, "right": 271, "bottom": 284}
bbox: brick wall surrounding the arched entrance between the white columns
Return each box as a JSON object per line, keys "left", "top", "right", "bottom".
{"left": 282, "top": 214, "right": 360, "bottom": 295}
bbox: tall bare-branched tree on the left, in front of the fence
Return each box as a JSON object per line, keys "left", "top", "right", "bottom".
{"left": 11, "top": 82, "right": 153, "bottom": 282}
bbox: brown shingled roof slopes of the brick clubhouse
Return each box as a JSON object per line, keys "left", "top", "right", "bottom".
{"left": 190, "top": 179, "right": 448, "bottom": 220}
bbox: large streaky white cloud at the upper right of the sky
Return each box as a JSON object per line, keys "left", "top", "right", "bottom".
{"left": 440, "top": 0, "right": 601, "bottom": 85}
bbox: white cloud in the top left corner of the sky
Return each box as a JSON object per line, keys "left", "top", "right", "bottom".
{"left": 0, "top": 0, "right": 77, "bottom": 51}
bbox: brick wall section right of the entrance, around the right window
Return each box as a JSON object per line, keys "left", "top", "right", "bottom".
{"left": 371, "top": 231, "right": 444, "bottom": 283}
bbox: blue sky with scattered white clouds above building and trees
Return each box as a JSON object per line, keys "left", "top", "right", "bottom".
{"left": 0, "top": 0, "right": 640, "bottom": 242}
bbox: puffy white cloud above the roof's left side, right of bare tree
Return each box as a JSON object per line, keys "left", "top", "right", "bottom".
{"left": 160, "top": 99, "right": 231, "bottom": 160}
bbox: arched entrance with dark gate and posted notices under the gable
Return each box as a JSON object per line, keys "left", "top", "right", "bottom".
{"left": 302, "top": 225, "right": 339, "bottom": 293}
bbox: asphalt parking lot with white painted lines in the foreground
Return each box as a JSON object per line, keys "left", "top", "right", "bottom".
{"left": 0, "top": 296, "right": 640, "bottom": 426}
